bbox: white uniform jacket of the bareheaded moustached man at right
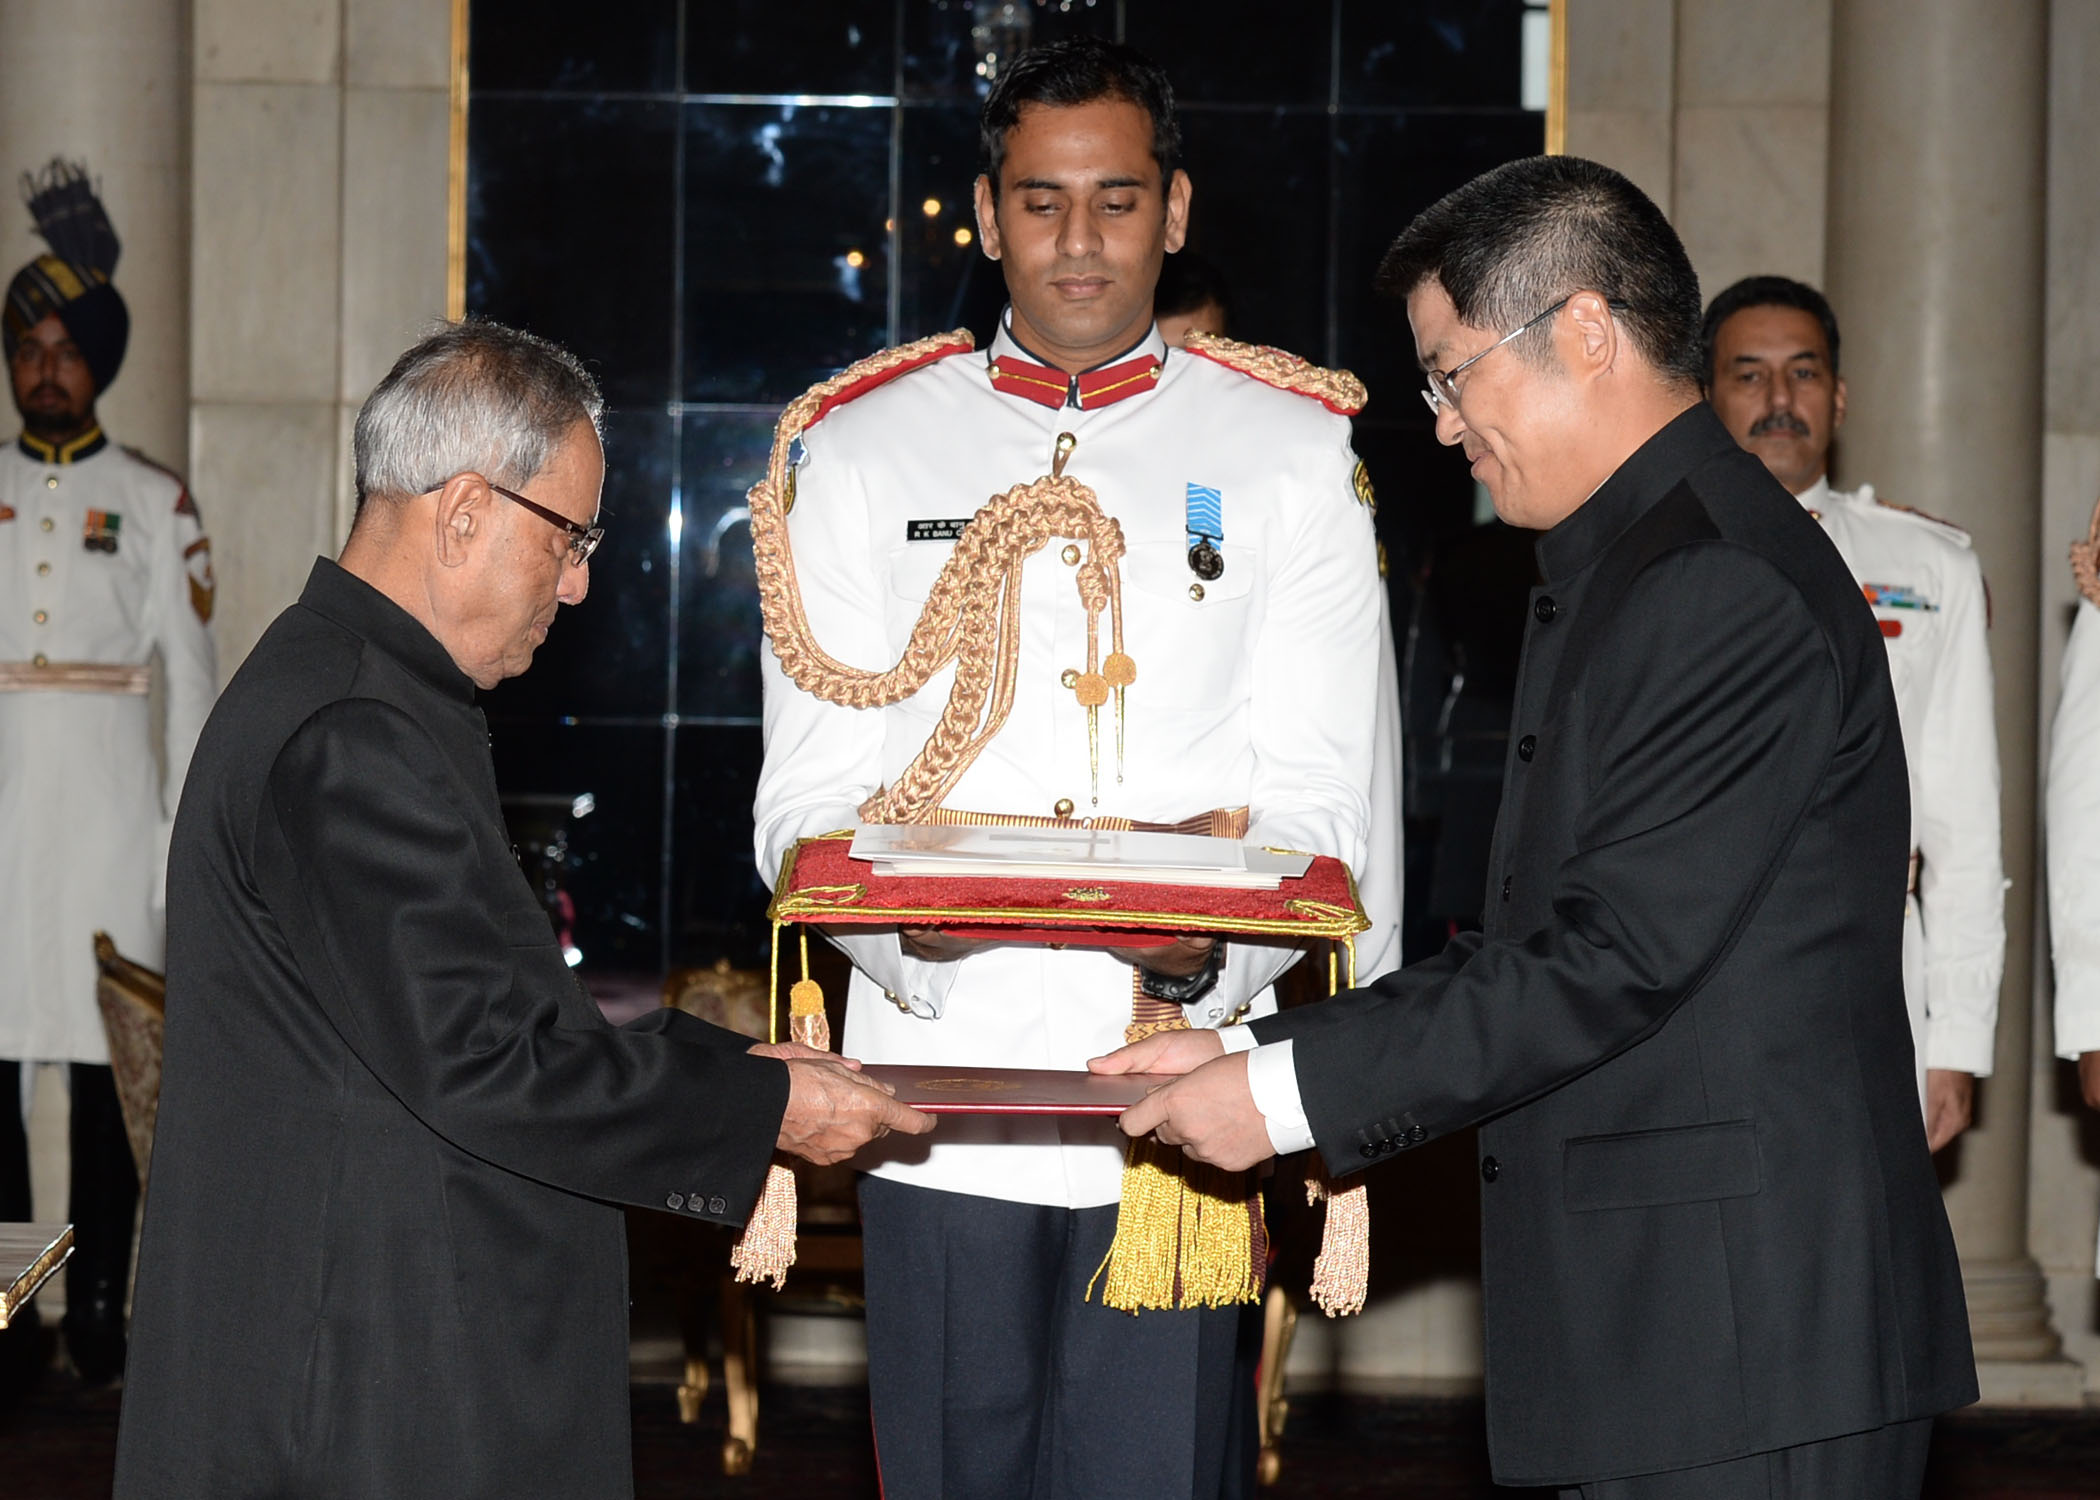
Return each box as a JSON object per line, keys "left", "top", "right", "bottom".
{"left": 1800, "top": 479, "right": 2006, "bottom": 1088}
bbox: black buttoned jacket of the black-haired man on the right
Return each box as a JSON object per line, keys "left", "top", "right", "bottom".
{"left": 1254, "top": 405, "right": 1976, "bottom": 1485}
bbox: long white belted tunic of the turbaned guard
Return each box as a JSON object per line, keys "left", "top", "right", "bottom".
{"left": 0, "top": 437, "right": 216, "bottom": 1063}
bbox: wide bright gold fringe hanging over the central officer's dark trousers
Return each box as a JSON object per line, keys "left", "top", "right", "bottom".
{"left": 1086, "top": 1137, "right": 1266, "bottom": 1313}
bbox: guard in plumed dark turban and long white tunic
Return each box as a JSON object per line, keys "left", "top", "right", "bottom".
{"left": 0, "top": 160, "right": 214, "bottom": 1384}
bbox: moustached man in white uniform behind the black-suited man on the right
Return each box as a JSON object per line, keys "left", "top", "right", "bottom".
{"left": 1705, "top": 275, "right": 2006, "bottom": 1151}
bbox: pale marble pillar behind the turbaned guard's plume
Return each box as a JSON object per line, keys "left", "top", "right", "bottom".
{"left": 0, "top": 0, "right": 189, "bottom": 468}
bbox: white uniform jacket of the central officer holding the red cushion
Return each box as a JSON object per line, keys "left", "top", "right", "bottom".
{"left": 756, "top": 319, "right": 1399, "bottom": 1208}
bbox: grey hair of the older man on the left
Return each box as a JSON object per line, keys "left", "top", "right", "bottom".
{"left": 355, "top": 319, "right": 605, "bottom": 513}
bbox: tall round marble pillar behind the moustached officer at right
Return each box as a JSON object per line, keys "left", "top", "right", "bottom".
{"left": 1827, "top": 0, "right": 2083, "bottom": 1405}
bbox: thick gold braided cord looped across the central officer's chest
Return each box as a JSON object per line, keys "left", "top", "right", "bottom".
{"left": 750, "top": 332, "right": 1128, "bottom": 824}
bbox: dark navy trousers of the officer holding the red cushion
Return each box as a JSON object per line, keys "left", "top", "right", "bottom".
{"left": 861, "top": 1176, "right": 1241, "bottom": 1500}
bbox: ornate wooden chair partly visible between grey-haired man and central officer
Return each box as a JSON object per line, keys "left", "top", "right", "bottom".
{"left": 664, "top": 954, "right": 863, "bottom": 1475}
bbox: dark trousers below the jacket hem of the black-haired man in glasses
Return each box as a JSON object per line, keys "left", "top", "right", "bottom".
{"left": 1560, "top": 1416, "right": 1932, "bottom": 1500}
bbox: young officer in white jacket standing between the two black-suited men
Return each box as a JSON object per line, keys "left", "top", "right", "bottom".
{"left": 756, "top": 38, "right": 1399, "bottom": 1500}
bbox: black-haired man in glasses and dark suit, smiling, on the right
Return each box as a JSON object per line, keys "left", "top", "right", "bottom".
{"left": 1096, "top": 158, "right": 1976, "bottom": 1500}
